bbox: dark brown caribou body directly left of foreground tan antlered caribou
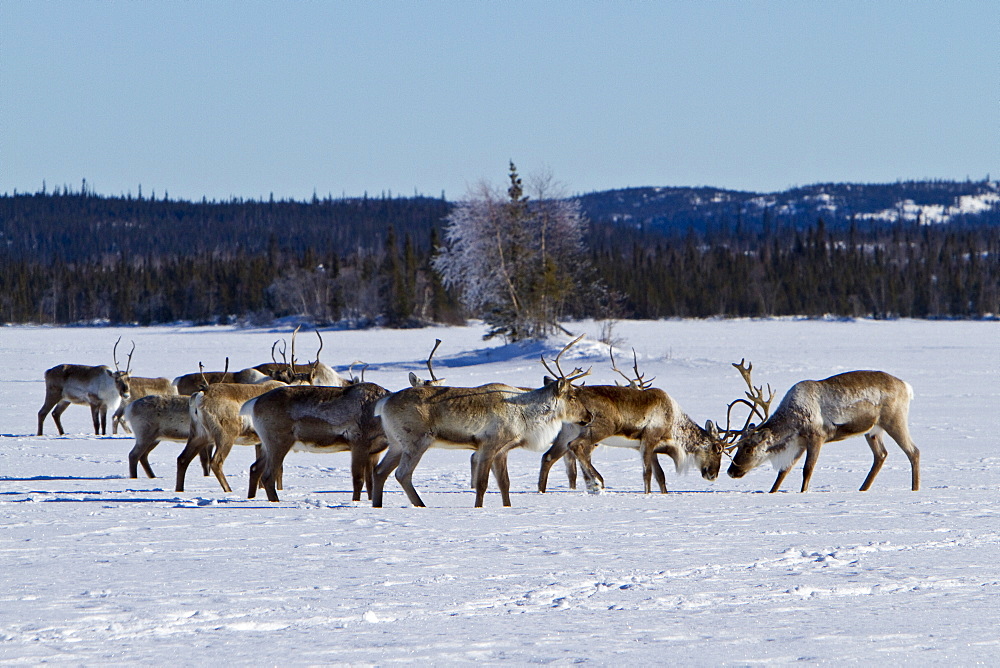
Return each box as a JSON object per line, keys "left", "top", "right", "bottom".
{"left": 240, "top": 382, "right": 389, "bottom": 501}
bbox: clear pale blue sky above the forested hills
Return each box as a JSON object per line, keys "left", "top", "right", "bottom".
{"left": 0, "top": 0, "right": 1000, "bottom": 199}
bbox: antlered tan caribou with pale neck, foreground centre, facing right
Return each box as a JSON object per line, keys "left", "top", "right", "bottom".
{"left": 372, "top": 338, "right": 592, "bottom": 508}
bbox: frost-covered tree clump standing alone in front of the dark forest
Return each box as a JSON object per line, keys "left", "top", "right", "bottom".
{"left": 434, "top": 162, "right": 586, "bottom": 341}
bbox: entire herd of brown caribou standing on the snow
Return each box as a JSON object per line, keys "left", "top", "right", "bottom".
{"left": 31, "top": 328, "right": 920, "bottom": 508}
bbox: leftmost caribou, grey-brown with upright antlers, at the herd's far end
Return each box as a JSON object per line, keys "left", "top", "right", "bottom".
{"left": 38, "top": 337, "right": 135, "bottom": 436}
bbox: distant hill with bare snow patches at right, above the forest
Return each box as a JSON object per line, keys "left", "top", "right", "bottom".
{"left": 579, "top": 180, "right": 1000, "bottom": 233}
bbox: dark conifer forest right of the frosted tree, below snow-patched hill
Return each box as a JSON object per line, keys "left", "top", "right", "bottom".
{"left": 591, "top": 218, "right": 1000, "bottom": 318}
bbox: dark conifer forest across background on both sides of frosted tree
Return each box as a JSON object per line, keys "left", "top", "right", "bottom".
{"left": 0, "top": 187, "right": 1000, "bottom": 333}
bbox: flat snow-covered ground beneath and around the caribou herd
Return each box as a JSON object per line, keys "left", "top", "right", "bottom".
{"left": 0, "top": 320, "right": 1000, "bottom": 665}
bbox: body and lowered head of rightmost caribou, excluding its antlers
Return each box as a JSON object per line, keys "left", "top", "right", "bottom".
{"left": 729, "top": 371, "right": 920, "bottom": 493}
